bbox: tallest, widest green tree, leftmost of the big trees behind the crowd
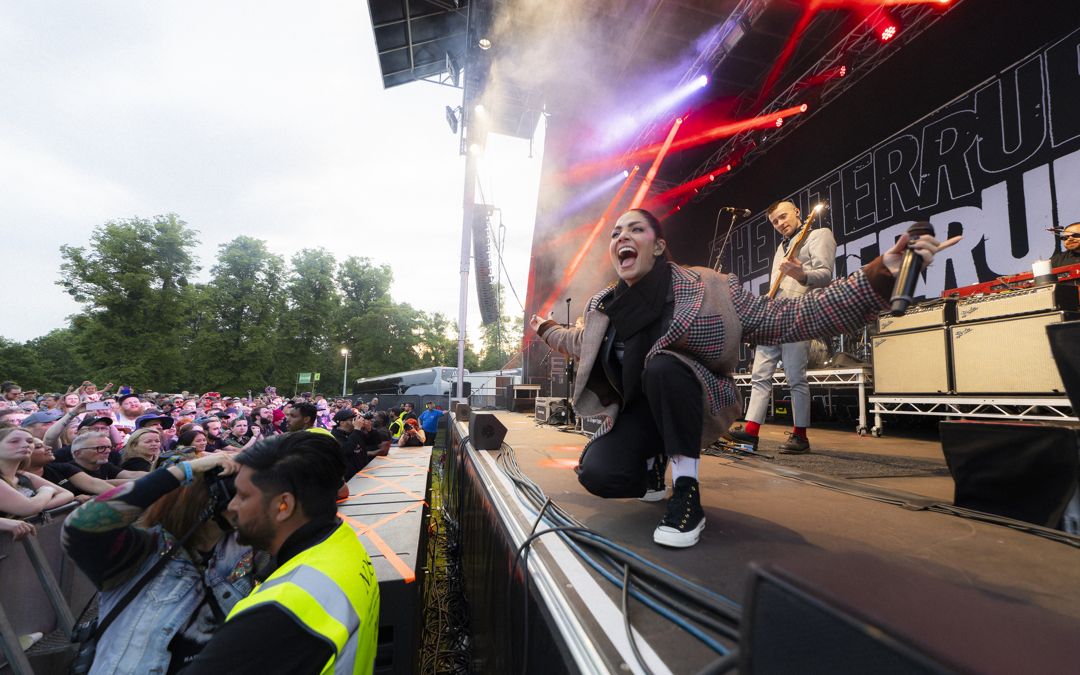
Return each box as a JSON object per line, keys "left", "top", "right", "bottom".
{"left": 57, "top": 214, "right": 199, "bottom": 391}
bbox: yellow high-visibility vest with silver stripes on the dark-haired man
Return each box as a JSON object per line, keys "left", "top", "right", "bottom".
{"left": 226, "top": 523, "right": 379, "bottom": 675}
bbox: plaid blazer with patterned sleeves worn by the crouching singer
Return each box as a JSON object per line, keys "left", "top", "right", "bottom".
{"left": 540, "top": 260, "right": 888, "bottom": 447}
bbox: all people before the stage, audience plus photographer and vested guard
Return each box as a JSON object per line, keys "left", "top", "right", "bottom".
{"left": 0, "top": 381, "right": 443, "bottom": 674}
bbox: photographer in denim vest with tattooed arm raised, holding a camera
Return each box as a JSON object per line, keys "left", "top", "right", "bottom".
{"left": 63, "top": 448, "right": 267, "bottom": 675}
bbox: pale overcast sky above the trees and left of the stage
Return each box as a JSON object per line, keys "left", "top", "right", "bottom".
{"left": 0, "top": 0, "right": 542, "bottom": 341}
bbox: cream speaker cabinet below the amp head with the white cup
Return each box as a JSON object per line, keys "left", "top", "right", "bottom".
{"left": 949, "top": 312, "right": 1071, "bottom": 394}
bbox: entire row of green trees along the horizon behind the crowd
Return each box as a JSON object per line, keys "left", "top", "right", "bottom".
{"left": 0, "top": 214, "right": 522, "bottom": 393}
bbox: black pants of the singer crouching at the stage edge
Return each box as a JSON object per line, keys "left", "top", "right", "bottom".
{"left": 578, "top": 354, "right": 703, "bottom": 498}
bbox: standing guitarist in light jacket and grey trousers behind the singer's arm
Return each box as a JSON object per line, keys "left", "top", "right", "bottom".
{"left": 732, "top": 201, "right": 836, "bottom": 455}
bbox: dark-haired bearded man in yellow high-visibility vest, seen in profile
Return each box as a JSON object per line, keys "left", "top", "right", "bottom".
{"left": 184, "top": 431, "right": 379, "bottom": 675}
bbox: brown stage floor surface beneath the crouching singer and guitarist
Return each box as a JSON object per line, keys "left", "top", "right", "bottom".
{"left": 481, "top": 413, "right": 1080, "bottom": 672}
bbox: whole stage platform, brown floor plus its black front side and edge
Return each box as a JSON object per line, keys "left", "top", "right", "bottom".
{"left": 448, "top": 413, "right": 1080, "bottom": 673}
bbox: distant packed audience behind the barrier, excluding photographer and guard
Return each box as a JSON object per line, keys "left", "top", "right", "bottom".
{"left": 0, "top": 381, "right": 443, "bottom": 520}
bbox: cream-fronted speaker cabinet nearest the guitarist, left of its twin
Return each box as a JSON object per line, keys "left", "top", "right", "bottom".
{"left": 873, "top": 326, "right": 951, "bottom": 394}
